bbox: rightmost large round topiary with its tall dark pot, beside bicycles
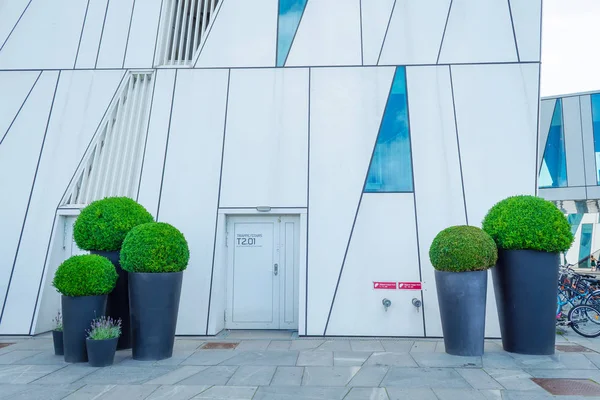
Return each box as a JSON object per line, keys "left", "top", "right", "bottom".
{"left": 483, "top": 196, "right": 573, "bottom": 355}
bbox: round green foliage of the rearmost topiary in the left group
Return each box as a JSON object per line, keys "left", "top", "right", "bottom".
{"left": 73, "top": 197, "right": 154, "bottom": 251}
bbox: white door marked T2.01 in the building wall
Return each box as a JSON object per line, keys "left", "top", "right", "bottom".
{"left": 225, "top": 216, "right": 300, "bottom": 329}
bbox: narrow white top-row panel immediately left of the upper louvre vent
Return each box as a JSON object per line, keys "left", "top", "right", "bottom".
{"left": 125, "top": 0, "right": 162, "bottom": 68}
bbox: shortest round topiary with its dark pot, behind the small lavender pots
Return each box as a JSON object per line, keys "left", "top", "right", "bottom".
{"left": 52, "top": 254, "right": 118, "bottom": 362}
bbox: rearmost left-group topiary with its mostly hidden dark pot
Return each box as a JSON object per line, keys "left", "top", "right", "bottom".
{"left": 73, "top": 197, "right": 154, "bottom": 349}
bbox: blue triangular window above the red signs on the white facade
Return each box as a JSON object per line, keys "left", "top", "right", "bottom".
{"left": 365, "top": 67, "right": 413, "bottom": 193}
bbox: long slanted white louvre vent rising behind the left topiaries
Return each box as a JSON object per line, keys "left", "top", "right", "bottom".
{"left": 61, "top": 72, "right": 154, "bottom": 206}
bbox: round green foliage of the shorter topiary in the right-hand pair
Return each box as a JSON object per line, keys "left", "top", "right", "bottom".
{"left": 429, "top": 225, "right": 498, "bottom": 272}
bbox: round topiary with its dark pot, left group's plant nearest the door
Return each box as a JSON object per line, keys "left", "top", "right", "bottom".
{"left": 121, "top": 222, "right": 190, "bottom": 360}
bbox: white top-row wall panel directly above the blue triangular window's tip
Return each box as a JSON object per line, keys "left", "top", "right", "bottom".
{"left": 379, "top": 0, "right": 450, "bottom": 65}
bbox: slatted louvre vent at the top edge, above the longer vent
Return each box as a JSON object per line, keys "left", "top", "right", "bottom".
{"left": 157, "top": 0, "right": 220, "bottom": 65}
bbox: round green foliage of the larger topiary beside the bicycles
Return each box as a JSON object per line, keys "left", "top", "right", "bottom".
{"left": 483, "top": 196, "right": 574, "bottom": 253}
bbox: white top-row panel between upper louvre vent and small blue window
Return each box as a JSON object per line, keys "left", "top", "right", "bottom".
{"left": 196, "top": 0, "right": 278, "bottom": 67}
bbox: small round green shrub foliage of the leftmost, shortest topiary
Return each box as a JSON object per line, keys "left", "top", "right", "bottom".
{"left": 52, "top": 254, "right": 119, "bottom": 297}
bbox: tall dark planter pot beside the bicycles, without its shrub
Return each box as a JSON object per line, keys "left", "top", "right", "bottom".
{"left": 492, "top": 250, "right": 560, "bottom": 355}
